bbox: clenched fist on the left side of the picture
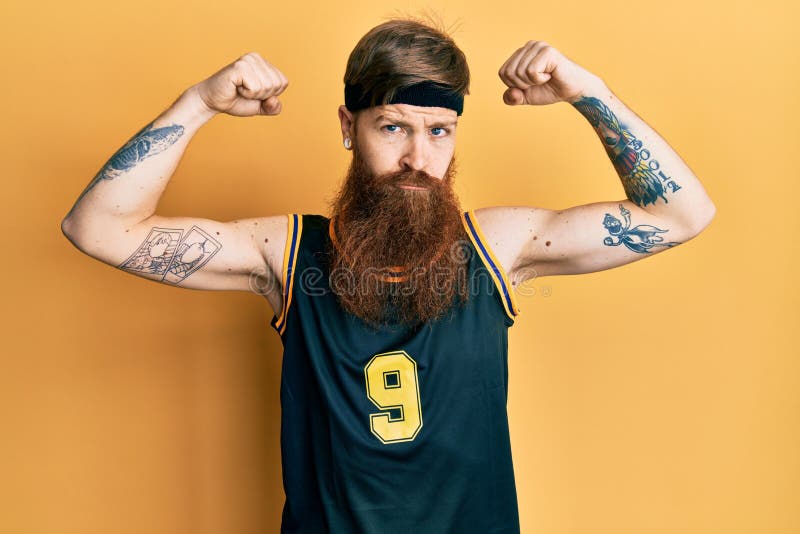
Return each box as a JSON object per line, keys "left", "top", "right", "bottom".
{"left": 196, "top": 52, "right": 289, "bottom": 117}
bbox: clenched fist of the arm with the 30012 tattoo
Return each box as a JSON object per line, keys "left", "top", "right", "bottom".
{"left": 497, "top": 41, "right": 602, "bottom": 106}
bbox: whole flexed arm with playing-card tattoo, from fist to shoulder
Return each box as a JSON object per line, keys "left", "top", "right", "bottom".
{"left": 61, "top": 54, "right": 288, "bottom": 313}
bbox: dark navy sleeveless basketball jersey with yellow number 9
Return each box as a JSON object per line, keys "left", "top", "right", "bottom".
{"left": 271, "top": 212, "right": 519, "bottom": 534}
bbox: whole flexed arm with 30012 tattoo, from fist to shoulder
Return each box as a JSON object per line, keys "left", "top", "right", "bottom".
{"left": 476, "top": 41, "right": 715, "bottom": 283}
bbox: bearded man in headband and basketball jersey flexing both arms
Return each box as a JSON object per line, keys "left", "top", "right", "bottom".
{"left": 62, "top": 16, "right": 715, "bottom": 533}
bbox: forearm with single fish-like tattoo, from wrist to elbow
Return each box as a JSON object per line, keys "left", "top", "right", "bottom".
{"left": 62, "top": 86, "right": 215, "bottom": 231}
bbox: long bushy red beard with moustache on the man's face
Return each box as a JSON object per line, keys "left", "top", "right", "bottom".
{"left": 329, "top": 143, "right": 467, "bottom": 327}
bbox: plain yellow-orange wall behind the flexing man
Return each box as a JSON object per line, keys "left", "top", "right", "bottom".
{"left": 0, "top": 0, "right": 800, "bottom": 534}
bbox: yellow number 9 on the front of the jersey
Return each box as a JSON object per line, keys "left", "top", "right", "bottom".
{"left": 364, "top": 350, "right": 422, "bottom": 443}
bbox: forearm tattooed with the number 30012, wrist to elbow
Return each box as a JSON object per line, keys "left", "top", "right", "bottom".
{"left": 571, "top": 81, "right": 715, "bottom": 231}
